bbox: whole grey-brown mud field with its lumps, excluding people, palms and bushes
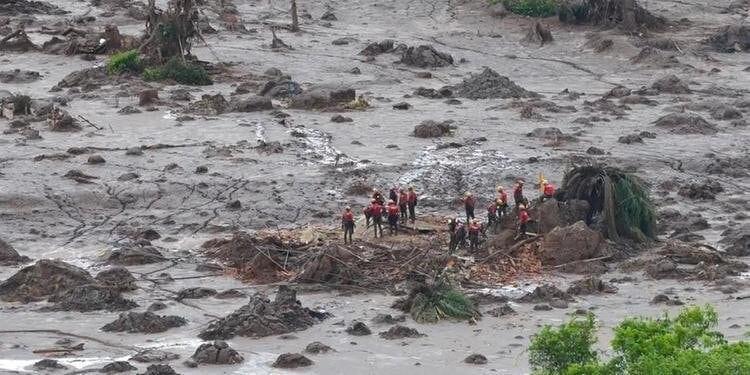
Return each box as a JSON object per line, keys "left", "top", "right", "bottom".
{"left": 0, "top": 0, "right": 750, "bottom": 375}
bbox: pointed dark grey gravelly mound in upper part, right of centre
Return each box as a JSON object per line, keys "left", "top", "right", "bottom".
{"left": 452, "top": 68, "right": 539, "bottom": 99}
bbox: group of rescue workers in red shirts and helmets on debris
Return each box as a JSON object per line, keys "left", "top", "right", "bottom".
{"left": 341, "top": 179, "right": 555, "bottom": 253}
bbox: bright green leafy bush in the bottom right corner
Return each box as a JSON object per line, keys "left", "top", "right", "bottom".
{"left": 529, "top": 306, "right": 750, "bottom": 375}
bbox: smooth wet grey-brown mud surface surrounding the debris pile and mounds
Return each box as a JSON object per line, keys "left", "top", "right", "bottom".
{"left": 0, "top": 0, "right": 750, "bottom": 374}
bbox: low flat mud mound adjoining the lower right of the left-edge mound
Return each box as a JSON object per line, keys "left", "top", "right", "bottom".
{"left": 45, "top": 284, "right": 138, "bottom": 312}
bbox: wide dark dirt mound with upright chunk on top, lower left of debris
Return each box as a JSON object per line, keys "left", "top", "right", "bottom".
{"left": 199, "top": 286, "right": 328, "bottom": 340}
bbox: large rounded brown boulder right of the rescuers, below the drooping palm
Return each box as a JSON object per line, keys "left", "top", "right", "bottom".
{"left": 540, "top": 221, "right": 606, "bottom": 266}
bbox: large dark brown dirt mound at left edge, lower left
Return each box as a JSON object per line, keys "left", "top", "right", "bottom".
{"left": 0, "top": 259, "right": 95, "bottom": 302}
